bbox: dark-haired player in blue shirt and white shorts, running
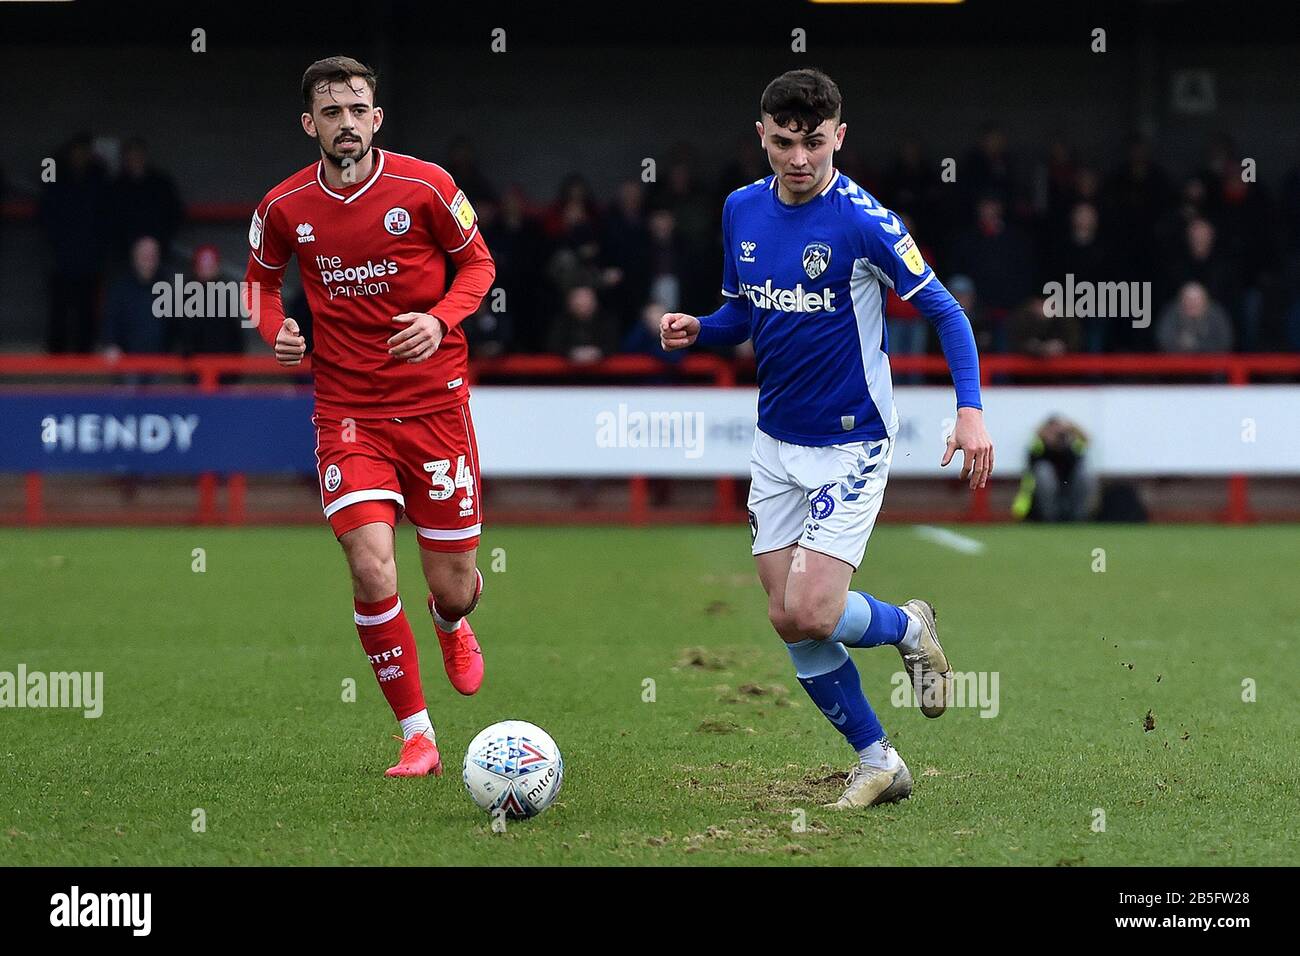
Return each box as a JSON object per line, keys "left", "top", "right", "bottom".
{"left": 660, "top": 69, "right": 993, "bottom": 808}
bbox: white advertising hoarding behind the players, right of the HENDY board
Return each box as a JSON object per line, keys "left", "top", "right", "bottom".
{"left": 471, "top": 385, "right": 1300, "bottom": 477}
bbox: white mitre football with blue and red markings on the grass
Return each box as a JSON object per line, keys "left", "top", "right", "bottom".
{"left": 464, "top": 721, "right": 564, "bottom": 819}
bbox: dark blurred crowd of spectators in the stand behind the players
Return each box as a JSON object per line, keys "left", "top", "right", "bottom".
{"left": 20, "top": 125, "right": 1300, "bottom": 363}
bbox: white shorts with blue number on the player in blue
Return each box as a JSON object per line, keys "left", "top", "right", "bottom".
{"left": 749, "top": 429, "right": 894, "bottom": 568}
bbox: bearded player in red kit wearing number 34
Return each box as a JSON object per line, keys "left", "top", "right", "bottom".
{"left": 247, "top": 56, "right": 495, "bottom": 777}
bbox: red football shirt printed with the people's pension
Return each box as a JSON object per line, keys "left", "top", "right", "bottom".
{"left": 246, "top": 150, "right": 497, "bottom": 418}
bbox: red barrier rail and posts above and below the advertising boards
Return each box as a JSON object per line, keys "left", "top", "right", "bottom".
{"left": 0, "top": 354, "right": 1300, "bottom": 524}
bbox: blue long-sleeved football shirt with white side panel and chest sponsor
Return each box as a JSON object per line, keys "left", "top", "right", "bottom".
{"left": 699, "top": 173, "right": 980, "bottom": 446}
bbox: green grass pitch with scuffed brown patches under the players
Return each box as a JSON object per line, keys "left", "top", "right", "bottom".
{"left": 0, "top": 525, "right": 1300, "bottom": 865}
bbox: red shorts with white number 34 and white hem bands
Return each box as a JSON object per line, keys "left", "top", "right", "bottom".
{"left": 312, "top": 403, "right": 482, "bottom": 551}
